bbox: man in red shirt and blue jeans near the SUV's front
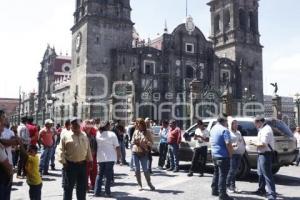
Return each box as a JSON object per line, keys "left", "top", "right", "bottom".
{"left": 167, "top": 120, "right": 181, "bottom": 172}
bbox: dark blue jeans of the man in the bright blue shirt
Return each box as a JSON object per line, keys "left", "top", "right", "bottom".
{"left": 211, "top": 158, "right": 230, "bottom": 199}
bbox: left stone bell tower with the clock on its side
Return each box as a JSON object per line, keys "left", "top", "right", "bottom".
{"left": 71, "top": 0, "right": 133, "bottom": 117}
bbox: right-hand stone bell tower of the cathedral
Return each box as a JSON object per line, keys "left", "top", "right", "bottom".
{"left": 208, "top": 0, "right": 263, "bottom": 102}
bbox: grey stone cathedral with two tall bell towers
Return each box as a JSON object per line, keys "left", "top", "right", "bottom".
{"left": 39, "top": 0, "right": 263, "bottom": 128}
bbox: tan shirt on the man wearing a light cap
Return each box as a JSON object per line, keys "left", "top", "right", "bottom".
{"left": 58, "top": 131, "right": 93, "bottom": 164}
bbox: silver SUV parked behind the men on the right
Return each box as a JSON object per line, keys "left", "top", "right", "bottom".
{"left": 179, "top": 117, "right": 298, "bottom": 177}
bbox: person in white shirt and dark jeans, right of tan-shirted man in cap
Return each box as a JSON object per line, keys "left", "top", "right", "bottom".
{"left": 94, "top": 121, "right": 121, "bottom": 197}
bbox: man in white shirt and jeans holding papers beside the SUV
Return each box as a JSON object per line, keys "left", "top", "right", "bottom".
{"left": 250, "top": 117, "right": 276, "bottom": 199}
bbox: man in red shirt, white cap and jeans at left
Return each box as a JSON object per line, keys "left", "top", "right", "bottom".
{"left": 39, "top": 119, "right": 55, "bottom": 175}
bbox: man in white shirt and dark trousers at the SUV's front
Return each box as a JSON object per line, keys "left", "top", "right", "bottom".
{"left": 187, "top": 120, "right": 209, "bottom": 177}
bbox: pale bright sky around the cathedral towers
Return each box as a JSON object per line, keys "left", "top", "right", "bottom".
{"left": 0, "top": 0, "right": 300, "bottom": 97}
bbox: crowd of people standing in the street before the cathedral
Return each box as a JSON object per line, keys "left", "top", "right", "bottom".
{"left": 0, "top": 108, "right": 300, "bottom": 200}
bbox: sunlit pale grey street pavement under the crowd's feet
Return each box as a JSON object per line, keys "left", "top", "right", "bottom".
{"left": 11, "top": 151, "right": 300, "bottom": 200}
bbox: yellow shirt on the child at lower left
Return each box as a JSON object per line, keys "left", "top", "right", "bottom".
{"left": 25, "top": 155, "right": 42, "bottom": 185}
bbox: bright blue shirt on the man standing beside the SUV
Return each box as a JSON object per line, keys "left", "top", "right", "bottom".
{"left": 210, "top": 123, "right": 230, "bottom": 158}
